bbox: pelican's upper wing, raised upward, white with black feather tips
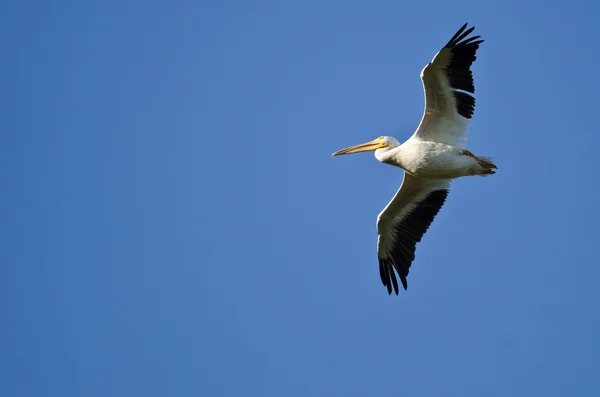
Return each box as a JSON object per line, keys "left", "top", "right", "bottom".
{"left": 413, "top": 24, "right": 483, "bottom": 148}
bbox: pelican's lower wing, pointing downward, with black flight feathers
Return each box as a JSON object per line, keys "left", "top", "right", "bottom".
{"left": 377, "top": 173, "right": 450, "bottom": 295}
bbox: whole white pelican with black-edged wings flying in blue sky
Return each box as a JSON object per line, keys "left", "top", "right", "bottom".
{"left": 333, "top": 24, "right": 496, "bottom": 295}
